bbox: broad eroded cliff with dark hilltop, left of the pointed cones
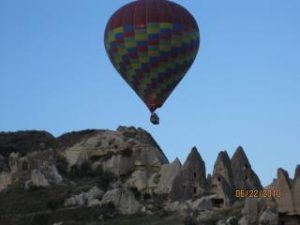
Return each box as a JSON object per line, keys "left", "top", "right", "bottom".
{"left": 0, "top": 127, "right": 168, "bottom": 191}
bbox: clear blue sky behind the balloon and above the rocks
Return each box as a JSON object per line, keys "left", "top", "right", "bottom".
{"left": 0, "top": 0, "right": 300, "bottom": 185}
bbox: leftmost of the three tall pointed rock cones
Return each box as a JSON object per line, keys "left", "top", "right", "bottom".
{"left": 171, "top": 147, "right": 207, "bottom": 201}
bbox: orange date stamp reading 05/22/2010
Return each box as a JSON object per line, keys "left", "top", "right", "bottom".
{"left": 235, "top": 189, "right": 281, "bottom": 198}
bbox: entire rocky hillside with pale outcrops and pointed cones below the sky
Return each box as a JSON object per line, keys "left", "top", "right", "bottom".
{"left": 0, "top": 127, "right": 300, "bottom": 225}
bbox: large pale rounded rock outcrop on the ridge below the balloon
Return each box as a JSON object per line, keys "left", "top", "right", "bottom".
{"left": 65, "top": 127, "right": 168, "bottom": 191}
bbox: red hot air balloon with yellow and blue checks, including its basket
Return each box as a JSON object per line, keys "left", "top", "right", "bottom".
{"left": 104, "top": 0, "right": 200, "bottom": 124}
